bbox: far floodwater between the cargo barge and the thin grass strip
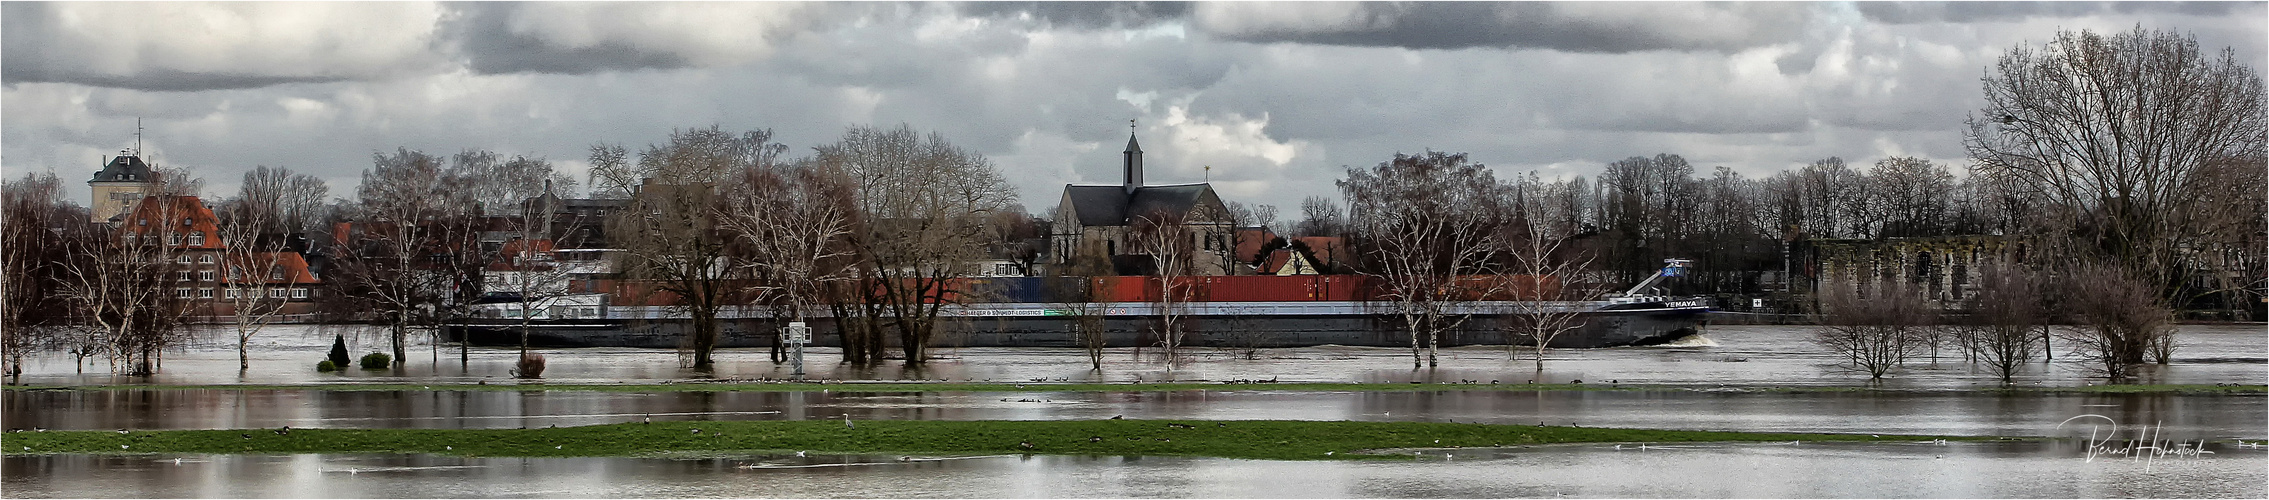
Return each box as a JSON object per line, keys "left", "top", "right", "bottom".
{"left": 8, "top": 325, "right": 2269, "bottom": 389}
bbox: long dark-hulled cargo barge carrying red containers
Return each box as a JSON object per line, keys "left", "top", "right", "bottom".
{"left": 447, "top": 264, "right": 1709, "bottom": 348}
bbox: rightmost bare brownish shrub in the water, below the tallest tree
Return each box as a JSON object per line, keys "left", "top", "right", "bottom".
{"left": 2058, "top": 261, "right": 2174, "bottom": 380}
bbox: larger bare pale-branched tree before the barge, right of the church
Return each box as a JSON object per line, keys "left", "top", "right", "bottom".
{"left": 1339, "top": 150, "right": 1504, "bottom": 366}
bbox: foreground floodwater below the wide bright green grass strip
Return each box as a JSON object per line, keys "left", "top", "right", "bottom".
{"left": 0, "top": 441, "right": 2269, "bottom": 498}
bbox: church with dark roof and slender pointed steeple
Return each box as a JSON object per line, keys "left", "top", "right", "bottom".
{"left": 1051, "top": 127, "right": 1234, "bottom": 275}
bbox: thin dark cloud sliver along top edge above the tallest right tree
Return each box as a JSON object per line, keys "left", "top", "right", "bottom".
{"left": 1856, "top": 2, "right": 2262, "bottom": 25}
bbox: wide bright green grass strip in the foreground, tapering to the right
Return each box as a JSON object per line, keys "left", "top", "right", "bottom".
{"left": 0, "top": 420, "right": 1985, "bottom": 459}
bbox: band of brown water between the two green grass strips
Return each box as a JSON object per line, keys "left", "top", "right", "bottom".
{"left": 0, "top": 389, "right": 2269, "bottom": 439}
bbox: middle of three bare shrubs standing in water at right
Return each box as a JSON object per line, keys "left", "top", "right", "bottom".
{"left": 1965, "top": 264, "right": 2049, "bottom": 384}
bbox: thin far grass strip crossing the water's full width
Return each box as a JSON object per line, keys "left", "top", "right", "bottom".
{"left": 5, "top": 382, "right": 2269, "bottom": 395}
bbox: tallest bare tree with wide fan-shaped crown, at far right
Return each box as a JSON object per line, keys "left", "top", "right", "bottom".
{"left": 1963, "top": 27, "right": 2269, "bottom": 297}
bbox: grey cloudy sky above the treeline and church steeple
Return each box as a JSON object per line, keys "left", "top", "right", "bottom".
{"left": 0, "top": 2, "right": 2269, "bottom": 214}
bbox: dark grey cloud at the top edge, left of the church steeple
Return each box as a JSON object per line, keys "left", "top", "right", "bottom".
{"left": 442, "top": 2, "right": 688, "bottom": 75}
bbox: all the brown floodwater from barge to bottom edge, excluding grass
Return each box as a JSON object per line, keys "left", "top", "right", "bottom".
{"left": 0, "top": 325, "right": 2269, "bottom": 498}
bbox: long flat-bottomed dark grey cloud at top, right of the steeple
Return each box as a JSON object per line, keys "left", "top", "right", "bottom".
{"left": 1198, "top": 2, "right": 1813, "bottom": 52}
